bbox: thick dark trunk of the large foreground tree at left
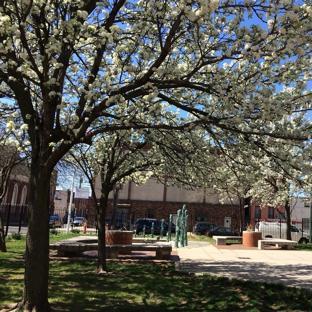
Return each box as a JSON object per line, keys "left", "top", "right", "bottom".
{"left": 22, "top": 160, "right": 52, "bottom": 312}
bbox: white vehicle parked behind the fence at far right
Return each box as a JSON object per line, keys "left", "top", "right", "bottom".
{"left": 255, "top": 221, "right": 309, "bottom": 244}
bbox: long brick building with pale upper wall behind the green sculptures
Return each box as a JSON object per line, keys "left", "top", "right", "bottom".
{"left": 87, "top": 178, "right": 242, "bottom": 230}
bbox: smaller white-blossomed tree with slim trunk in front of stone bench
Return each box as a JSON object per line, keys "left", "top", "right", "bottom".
{"left": 68, "top": 130, "right": 162, "bottom": 273}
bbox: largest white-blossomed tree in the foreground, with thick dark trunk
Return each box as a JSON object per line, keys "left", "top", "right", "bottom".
{"left": 0, "top": 0, "right": 311, "bottom": 311}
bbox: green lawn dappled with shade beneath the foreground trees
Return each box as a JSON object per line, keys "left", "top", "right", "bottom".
{"left": 0, "top": 234, "right": 312, "bottom": 312}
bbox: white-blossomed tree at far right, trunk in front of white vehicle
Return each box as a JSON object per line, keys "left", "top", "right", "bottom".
{"left": 248, "top": 136, "right": 312, "bottom": 240}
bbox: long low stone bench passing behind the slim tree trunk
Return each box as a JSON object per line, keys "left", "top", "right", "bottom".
{"left": 50, "top": 241, "right": 172, "bottom": 259}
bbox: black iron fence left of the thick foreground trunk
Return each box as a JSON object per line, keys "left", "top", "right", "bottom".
{"left": 0, "top": 204, "right": 27, "bottom": 235}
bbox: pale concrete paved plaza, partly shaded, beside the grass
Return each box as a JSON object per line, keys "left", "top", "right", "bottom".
{"left": 177, "top": 242, "right": 312, "bottom": 289}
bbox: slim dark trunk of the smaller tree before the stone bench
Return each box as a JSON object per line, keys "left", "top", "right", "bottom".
{"left": 98, "top": 191, "right": 108, "bottom": 273}
